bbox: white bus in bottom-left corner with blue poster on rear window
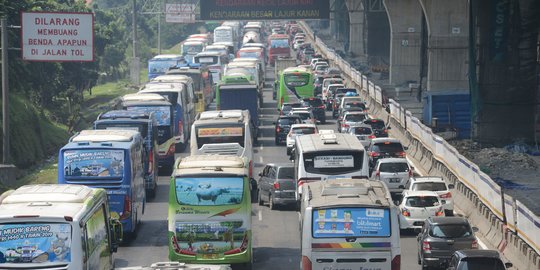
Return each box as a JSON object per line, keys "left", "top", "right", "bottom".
{"left": 0, "top": 184, "right": 122, "bottom": 270}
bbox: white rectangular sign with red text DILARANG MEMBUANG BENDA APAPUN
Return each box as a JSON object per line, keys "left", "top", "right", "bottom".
{"left": 21, "top": 12, "right": 94, "bottom": 62}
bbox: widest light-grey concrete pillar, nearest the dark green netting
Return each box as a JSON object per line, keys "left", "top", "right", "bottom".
{"left": 419, "top": 0, "right": 469, "bottom": 91}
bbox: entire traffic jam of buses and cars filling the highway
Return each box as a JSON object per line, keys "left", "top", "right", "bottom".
{"left": 0, "top": 21, "right": 512, "bottom": 270}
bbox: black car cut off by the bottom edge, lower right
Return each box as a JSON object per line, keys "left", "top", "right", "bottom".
{"left": 446, "top": 249, "right": 513, "bottom": 270}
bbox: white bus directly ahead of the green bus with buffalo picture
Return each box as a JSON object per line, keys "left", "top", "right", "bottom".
{"left": 190, "top": 110, "right": 254, "bottom": 178}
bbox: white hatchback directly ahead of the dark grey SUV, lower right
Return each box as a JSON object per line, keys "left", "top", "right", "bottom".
{"left": 398, "top": 190, "right": 444, "bottom": 230}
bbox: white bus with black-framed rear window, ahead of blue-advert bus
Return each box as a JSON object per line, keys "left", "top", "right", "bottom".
{"left": 291, "top": 133, "right": 369, "bottom": 200}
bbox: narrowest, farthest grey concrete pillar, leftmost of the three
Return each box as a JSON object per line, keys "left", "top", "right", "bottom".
{"left": 345, "top": 0, "right": 366, "bottom": 56}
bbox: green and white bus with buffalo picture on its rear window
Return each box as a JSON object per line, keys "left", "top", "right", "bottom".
{"left": 167, "top": 154, "right": 253, "bottom": 269}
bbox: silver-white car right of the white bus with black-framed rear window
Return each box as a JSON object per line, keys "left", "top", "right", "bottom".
{"left": 371, "top": 158, "right": 413, "bottom": 193}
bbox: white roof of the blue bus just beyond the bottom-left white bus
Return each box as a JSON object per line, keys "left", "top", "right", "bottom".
{"left": 70, "top": 129, "right": 140, "bottom": 142}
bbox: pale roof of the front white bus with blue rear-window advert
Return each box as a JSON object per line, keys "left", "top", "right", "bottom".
{"left": 305, "top": 178, "right": 393, "bottom": 207}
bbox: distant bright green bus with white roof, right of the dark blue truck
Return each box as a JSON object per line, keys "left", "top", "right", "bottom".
{"left": 277, "top": 67, "right": 315, "bottom": 110}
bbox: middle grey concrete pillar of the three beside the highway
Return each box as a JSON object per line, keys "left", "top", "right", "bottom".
{"left": 383, "top": 0, "right": 422, "bottom": 85}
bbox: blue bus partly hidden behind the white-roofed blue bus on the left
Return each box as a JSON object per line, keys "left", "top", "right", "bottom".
{"left": 94, "top": 110, "right": 159, "bottom": 200}
